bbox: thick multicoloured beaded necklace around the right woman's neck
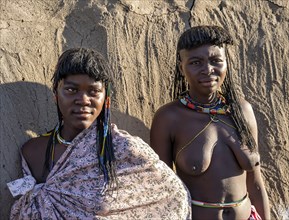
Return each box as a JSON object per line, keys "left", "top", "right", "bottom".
{"left": 179, "top": 92, "right": 230, "bottom": 115}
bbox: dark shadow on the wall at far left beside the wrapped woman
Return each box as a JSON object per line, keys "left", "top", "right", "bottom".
{"left": 0, "top": 81, "right": 56, "bottom": 219}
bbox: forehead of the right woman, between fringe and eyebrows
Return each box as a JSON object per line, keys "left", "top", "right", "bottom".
{"left": 180, "top": 44, "right": 226, "bottom": 58}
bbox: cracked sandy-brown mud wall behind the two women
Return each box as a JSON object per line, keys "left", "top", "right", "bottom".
{"left": 0, "top": 0, "right": 289, "bottom": 219}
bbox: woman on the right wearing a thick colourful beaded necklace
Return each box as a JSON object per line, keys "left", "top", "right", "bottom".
{"left": 151, "top": 26, "right": 270, "bottom": 220}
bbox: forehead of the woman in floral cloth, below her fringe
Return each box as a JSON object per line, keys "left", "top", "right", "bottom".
{"left": 59, "top": 74, "right": 104, "bottom": 86}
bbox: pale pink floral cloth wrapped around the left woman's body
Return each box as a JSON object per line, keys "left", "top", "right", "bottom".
{"left": 10, "top": 125, "right": 191, "bottom": 220}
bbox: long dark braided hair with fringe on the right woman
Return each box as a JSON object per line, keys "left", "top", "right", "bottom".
{"left": 172, "top": 26, "right": 257, "bottom": 152}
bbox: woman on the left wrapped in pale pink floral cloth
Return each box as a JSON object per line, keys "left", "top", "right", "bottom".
{"left": 8, "top": 48, "right": 191, "bottom": 220}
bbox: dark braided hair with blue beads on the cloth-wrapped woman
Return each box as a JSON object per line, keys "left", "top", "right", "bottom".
{"left": 44, "top": 48, "right": 116, "bottom": 184}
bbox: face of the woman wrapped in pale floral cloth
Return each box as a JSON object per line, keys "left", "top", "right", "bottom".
{"left": 56, "top": 74, "right": 105, "bottom": 135}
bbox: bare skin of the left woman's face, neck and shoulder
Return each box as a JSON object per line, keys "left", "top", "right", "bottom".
{"left": 22, "top": 74, "right": 105, "bottom": 183}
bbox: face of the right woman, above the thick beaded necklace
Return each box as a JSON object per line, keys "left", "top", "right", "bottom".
{"left": 179, "top": 44, "right": 227, "bottom": 101}
